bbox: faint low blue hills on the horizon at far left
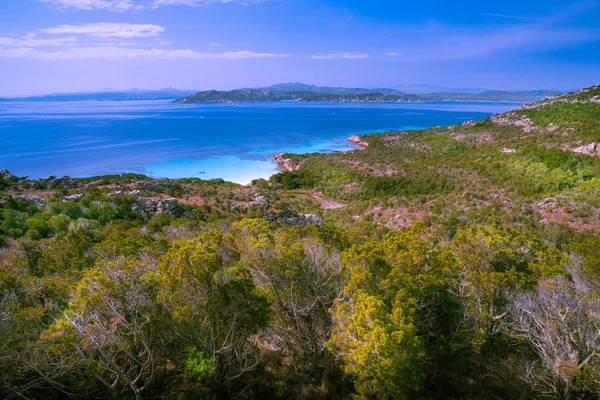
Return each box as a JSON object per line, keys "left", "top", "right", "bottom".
{"left": 0, "top": 88, "right": 196, "bottom": 101}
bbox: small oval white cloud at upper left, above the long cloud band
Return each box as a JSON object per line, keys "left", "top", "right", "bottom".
{"left": 42, "top": 22, "right": 165, "bottom": 38}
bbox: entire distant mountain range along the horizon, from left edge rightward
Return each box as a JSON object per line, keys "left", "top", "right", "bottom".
{"left": 0, "top": 82, "right": 559, "bottom": 103}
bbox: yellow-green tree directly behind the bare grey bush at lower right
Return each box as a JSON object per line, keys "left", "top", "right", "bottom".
{"left": 450, "top": 226, "right": 562, "bottom": 344}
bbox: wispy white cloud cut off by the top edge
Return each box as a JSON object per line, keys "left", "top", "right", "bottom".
{"left": 38, "top": 0, "right": 268, "bottom": 12}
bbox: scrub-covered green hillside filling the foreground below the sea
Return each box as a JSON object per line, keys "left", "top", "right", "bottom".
{"left": 0, "top": 86, "right": 600, "bottom": 400}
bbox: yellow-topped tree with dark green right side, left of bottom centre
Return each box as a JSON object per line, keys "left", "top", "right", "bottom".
{"left": 159, "top": 230, "right": 269, "bottom": 394}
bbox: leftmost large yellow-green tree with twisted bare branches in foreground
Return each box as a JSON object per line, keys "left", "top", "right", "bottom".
{"left": 41, "top": 259, "right": 166, "bottom": 399}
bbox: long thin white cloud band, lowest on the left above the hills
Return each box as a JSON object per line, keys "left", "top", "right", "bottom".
{"left": 0, "top": 46, "right": 290, "bottom": 60}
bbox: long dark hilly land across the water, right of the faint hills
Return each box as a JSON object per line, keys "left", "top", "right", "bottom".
{"left": 175, "top": 83, "right": 559, "bottom": 103}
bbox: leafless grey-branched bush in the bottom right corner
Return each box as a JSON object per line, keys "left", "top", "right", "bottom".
{"left": 509, "top": 258, "right": 600, "bottom": 399}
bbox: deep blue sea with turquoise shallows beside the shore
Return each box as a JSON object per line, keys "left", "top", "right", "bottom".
{"left": 0, "top": 101, "right": 516, "bottom": 183}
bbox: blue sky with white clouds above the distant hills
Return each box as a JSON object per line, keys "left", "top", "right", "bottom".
{"left": 0, "top": 0, "right": 600, "bottom": 96}
